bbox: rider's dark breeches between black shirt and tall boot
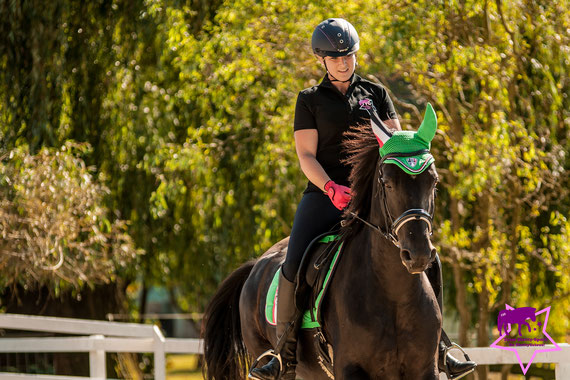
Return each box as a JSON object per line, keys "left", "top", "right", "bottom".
{"left": 282, "top": 192, "right": 342, "bottom": 281}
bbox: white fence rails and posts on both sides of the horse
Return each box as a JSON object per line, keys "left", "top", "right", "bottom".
{"left": 0, "top": 314, "right": 570, "bottom": 380}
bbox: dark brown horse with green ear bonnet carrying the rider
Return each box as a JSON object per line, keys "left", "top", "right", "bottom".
{"left": 204, "top": 109, "right": 441, "bottom": 380}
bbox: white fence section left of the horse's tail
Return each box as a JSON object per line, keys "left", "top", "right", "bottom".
{"left": 0, "top": 314, "right": 203, "bottom": 380}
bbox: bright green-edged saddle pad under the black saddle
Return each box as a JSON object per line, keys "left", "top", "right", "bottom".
{"left": 265, "top": 235, "right": 343, "bottom": 329}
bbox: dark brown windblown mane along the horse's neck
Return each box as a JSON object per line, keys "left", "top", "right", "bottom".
{"left": 343, "top": 124, "right": 380, "bottom": 230}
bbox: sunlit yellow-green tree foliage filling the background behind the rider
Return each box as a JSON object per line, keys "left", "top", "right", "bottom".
{"left": 0, "top": 0, "right": 570, "bottom": 368}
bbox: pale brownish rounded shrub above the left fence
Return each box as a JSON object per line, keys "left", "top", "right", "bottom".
{"left": 0, "top": 142, "right": 138, "bottom": 296}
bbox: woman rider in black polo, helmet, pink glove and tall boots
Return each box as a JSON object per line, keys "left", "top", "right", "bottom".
{"left": 249, "top": 18, "right": 474, "bottom": 380}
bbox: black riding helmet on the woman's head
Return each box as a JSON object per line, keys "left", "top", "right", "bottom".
{"left": 311, "top": 18, "right": 360, "bottom": 57}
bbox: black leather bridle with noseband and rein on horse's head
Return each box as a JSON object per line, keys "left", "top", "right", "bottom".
{"left": 350, "top": 149, "right": 435, "bottom": 248}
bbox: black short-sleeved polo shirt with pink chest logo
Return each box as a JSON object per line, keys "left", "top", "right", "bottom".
{"left": 294, "top": 74, "right": 397, "bottom": 192}
